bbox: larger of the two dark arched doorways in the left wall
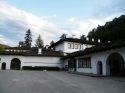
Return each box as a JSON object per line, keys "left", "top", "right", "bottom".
{"left": 10, "top": 58, "right": 21, "bottom": 70}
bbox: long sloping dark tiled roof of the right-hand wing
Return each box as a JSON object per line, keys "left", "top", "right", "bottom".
{"left": 64, "top": 42, "right": 125, "bottom": 58}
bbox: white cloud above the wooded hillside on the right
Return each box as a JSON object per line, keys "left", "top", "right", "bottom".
{"left": 67, "top": 12, "right": 124, "bottom": 37}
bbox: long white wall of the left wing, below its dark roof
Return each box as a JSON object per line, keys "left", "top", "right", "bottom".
{"left": 0, "top": 55, "right": 63, "bottom": 69}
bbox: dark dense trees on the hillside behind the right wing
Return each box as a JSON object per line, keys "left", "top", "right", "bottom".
{"left": 88, "top": 15, "right": 125, "bottom": 42}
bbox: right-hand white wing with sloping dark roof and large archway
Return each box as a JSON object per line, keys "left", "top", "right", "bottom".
{"left": 64, "top": 44, "right": 125, "bottom": 76}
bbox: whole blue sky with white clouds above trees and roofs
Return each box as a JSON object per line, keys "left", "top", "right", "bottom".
{"left": 0, "top": 0, "right": 125, "bottom": 46}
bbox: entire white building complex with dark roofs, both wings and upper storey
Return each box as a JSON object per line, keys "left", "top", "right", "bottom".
{"left": 0, "top": 38, "right": 125, "bottom": 76}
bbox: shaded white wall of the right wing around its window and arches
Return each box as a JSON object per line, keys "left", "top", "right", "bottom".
{"left": 65, "top": 47, "right": 125, "bottom": 75}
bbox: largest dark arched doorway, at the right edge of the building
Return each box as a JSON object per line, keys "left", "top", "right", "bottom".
{"left": 107, "top": 53, "right": 125, "bottom": 76}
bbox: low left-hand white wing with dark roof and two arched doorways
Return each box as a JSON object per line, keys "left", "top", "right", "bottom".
{"left": 0, "top": 48, "right": 63, "bottom": 70}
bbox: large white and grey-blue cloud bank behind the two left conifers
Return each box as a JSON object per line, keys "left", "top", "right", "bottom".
{"left": 0, "top": 2, "right": 67, "bottom": 45}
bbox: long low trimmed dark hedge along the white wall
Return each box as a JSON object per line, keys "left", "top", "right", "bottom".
{"left": 22, "top": 66, "right": 60, "bottom": 71}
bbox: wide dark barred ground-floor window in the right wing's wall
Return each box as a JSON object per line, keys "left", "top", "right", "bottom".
{"left": 78, "top": 57, "right": 91, "bottom": 68}
